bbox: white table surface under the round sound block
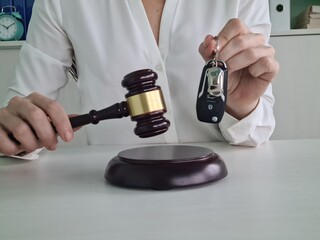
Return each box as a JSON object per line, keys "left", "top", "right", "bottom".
{"left": 0, "top": 140, "right": 320, "bottom": 240}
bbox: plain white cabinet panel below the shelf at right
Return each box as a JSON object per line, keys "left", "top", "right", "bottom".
{"left": 271, "top": 34, "right": 320, "bottom": 139}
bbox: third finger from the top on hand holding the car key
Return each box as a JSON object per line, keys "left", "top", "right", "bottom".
{"left": 227, "top": 46, "right": 274, "bottom": 76}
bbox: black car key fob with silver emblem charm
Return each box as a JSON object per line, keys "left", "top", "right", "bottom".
{"left": 196, "top": 59, "right": 228, "bottom": 123}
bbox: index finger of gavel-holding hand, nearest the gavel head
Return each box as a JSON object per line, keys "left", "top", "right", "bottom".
{"left": 28, "top": 93, "right": 73, "bottom": 142}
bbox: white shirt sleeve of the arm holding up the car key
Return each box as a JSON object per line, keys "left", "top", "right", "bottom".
{"left": 219, "top": 0, "right": 275, "bottom": 146}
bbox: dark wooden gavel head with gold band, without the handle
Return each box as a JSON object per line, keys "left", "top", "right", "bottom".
{"left": 122, "top": 69, "right": 170, "bottom": 138}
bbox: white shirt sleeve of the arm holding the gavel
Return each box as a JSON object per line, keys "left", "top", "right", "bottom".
{"left": 4, "top": 0, "right": 73, "bottom": 105}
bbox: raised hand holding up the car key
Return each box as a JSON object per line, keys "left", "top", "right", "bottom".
{"left": 199, "top": 19, "right": 279, "bottom": 119}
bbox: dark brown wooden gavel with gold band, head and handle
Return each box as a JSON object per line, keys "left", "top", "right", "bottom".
{"left": 9, "top": 69, "right": 170, "bottom": 144}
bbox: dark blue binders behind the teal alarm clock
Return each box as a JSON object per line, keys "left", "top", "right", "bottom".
{"left": 0, "top": 0, "right": 34, "bottom": 40}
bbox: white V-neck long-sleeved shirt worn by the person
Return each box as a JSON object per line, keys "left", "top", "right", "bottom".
{"left": 7, "top": 0, "right": 275, "bottom": 145}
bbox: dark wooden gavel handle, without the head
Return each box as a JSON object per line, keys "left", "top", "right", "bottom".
{"left": 8, "top": 102, "right": 129, "bottom": 145}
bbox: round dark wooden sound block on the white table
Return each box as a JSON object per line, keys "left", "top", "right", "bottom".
{"left": 105, "top": 145, "right": 228, "bottom": 190}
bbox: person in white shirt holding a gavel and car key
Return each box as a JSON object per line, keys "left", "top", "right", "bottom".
{"left": 0, "top": 0, "right": 279, "bottom": 155}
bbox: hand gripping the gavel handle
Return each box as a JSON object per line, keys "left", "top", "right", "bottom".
{"left": 0, "top": 93, "right": 73, "bottom": 155}
